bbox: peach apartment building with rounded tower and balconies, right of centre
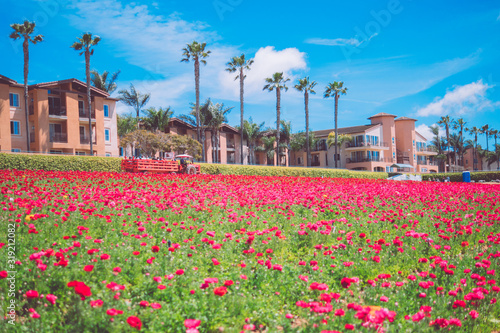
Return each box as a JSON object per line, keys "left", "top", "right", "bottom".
{"left": 291, "top": 113, "right": 438, "bottom": 173}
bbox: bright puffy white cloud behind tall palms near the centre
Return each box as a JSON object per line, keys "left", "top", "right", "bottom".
{"left": 219, "top": 46, "right": 307, "bottom": 102}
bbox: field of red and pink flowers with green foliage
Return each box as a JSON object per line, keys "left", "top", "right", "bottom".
{"left": 0, "top": 170, "right": 500, "bottom": 333}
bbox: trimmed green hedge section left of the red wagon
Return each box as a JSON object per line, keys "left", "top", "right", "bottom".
{"left": 0, "top": 153, "right": 122, "bottom": 171}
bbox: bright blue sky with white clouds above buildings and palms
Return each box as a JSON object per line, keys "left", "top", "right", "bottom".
{"left": 0, "top": 0, "right": 500, "bottom": 145}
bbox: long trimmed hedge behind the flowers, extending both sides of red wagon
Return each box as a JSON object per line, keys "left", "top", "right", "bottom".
{"left": 0, "top": 153, "right": 387, "bottom": 179}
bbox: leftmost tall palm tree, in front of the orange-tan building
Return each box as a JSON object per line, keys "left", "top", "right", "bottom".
{"left": 10, "top": 20, "right": 43, "bottom": 153}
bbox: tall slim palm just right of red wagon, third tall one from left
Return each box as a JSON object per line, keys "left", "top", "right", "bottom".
{"left": 181, "top": 41, "right": 211, "bottom": 161}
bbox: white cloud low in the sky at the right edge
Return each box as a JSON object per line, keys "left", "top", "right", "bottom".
{"left": 417, "top": 80, "right": 500, "bottom": 117}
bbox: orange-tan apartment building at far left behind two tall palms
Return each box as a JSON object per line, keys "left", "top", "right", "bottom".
{"left": 0, "top": 75, "right": 119, "bottom": 156}
